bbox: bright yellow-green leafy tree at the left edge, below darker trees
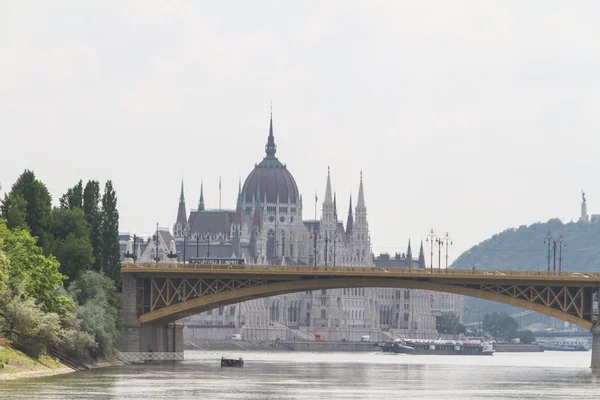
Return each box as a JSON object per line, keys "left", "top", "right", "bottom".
{"left": 0, "top": 220, "right": 75, "bottom": 316}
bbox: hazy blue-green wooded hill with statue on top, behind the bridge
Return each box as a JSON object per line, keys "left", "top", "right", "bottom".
{"left": 450, "top": 219, "right": 600, "bottom": 326}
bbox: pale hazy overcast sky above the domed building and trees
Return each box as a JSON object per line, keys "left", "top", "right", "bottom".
{"left": 0, "top": 0, "right": 600, "bottom": 264}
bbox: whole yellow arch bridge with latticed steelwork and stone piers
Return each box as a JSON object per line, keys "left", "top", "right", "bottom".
{"left": 121, "top": 263, "right": 600, "bottom": 367}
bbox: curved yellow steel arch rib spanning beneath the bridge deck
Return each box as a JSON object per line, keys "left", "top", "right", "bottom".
{"left": 139, "top": 277, "right": 593, "bottom": 329}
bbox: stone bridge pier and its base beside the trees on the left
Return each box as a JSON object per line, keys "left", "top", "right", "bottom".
{"left": 119, "top": 274, "right": 183, "bottom": 359}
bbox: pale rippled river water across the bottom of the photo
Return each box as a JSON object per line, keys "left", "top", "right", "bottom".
{"left": 0, "top": 351, "right": 600, "bottom": 400}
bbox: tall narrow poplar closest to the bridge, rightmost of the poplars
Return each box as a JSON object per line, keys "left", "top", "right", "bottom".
{"left": 102, "top": 181, "right": 121, "bottom": 285}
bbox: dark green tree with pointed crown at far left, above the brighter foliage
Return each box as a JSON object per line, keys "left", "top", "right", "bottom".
{"left": 3, "top": 170, "right": 52, "bottom": 248}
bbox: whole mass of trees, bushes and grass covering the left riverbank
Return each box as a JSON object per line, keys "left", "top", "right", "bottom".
{"left": 0, "top": 170, "right": 121, "bottom": 379}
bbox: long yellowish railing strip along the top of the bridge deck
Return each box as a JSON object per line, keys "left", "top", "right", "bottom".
{"left": 122, "top": 262, "right": 600, "bottom": 280}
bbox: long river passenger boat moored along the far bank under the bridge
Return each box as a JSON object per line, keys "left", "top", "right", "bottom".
{"left": 375, "top": 339, "right": 494, "bottom": 356}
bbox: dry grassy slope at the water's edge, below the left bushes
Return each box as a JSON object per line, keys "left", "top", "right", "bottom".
{"left": 0, "top": 338, "right": 72, "bottom": 380}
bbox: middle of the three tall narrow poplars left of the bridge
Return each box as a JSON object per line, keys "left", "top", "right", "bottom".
{"left": 83, "top": 181, "right": 104, "bottom": 271}
